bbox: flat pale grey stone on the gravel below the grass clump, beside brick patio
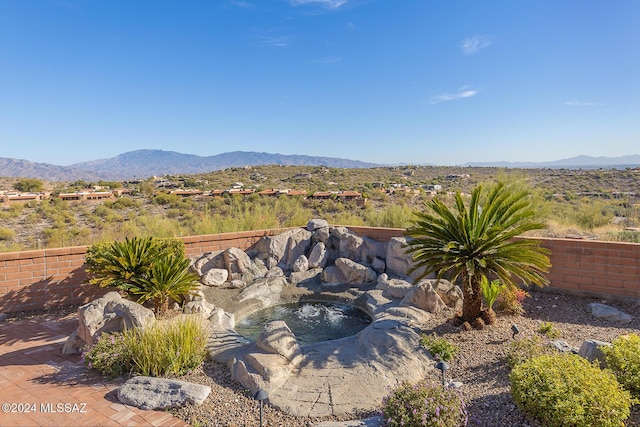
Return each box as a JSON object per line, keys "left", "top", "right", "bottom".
{"left": 118, "top": 376, "right": 211, "bottom": 410}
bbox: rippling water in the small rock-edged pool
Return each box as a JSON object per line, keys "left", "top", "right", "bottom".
{"left": 236, "top": 302, "right": 371, "bottom": 345}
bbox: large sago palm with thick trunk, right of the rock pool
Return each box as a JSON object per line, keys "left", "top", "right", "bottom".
{"left": 406, "top": 182, "right": 550, "bottom": 322}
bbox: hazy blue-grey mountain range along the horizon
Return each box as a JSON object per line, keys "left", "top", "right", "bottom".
{"left": 0, "top": 150, "right": 640, "bottom": 181}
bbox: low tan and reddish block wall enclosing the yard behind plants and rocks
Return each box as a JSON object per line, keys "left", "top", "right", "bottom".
{"left": 0, "top": 227, "right": 640, "bottom": 313}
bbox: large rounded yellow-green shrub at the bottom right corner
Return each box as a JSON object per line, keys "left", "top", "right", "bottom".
{"left": 510, "top": 353, "right": 633, "bottom": 427}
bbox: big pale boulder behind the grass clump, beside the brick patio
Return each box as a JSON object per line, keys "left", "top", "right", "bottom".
{"left": 78, "top": 292, "right": 155, "bottom": 345}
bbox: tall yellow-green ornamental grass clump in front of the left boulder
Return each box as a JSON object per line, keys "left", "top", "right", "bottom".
{"left": 125, "top": 316, "right": 208, "bottom": 377}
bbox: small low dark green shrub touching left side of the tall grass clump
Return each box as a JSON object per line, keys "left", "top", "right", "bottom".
{"left": 82, "top": 332, "right": 133, "bottom": 378}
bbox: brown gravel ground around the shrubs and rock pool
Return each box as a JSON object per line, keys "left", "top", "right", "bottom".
{"left": 175, "top": 291, "right": 640, "bottom": 427}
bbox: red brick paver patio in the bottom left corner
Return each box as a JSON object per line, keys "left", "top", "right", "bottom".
{"left": 0, "top": 315, "right": 188, "bottom": 427}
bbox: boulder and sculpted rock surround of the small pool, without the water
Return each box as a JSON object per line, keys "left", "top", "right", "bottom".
{"left": 192, "top": 220, "right": 462, "bottom": 417}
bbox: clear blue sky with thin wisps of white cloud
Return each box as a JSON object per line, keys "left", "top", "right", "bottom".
{"left": 0, "top": 0, "right": 640, "bottom": 166}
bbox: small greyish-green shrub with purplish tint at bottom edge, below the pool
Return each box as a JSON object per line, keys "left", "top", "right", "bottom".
{"left": 382, "top": 382, "right": 469, "bottom": 427}
